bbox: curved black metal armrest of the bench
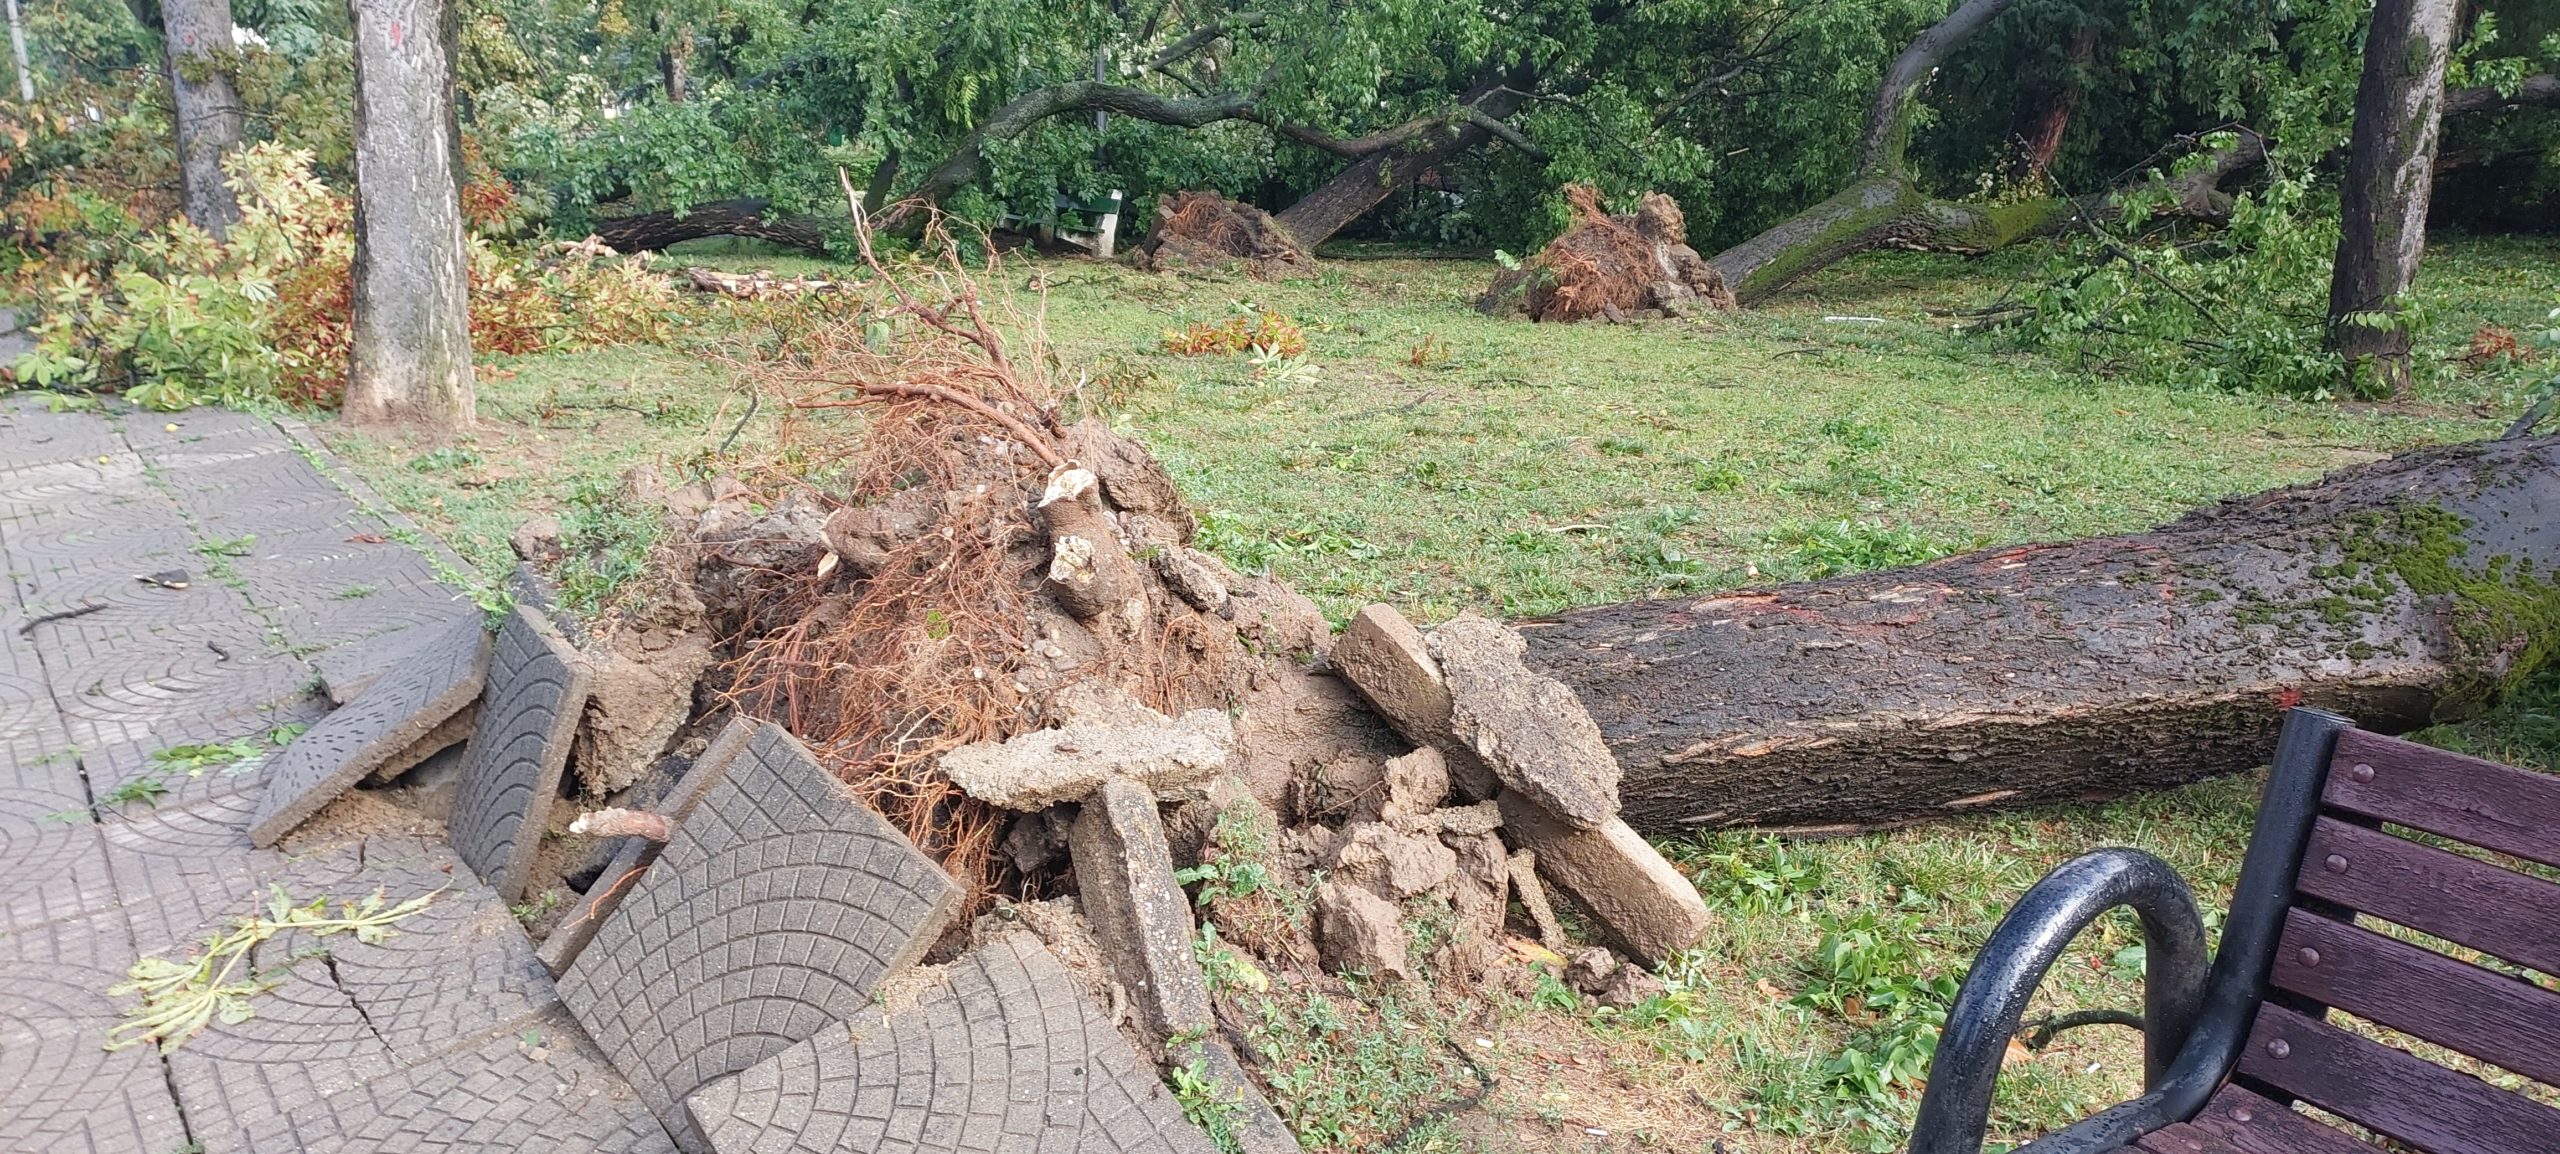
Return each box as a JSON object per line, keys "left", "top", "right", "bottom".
{"left": 1910, "top": 850, "right": 2207, "bottom": 1154}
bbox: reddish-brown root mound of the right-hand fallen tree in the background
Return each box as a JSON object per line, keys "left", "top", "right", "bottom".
{"left": 1475, "top": 184, "right": 1733, "bottom": 322}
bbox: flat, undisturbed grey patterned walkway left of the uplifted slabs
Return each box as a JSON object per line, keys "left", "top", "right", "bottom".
{"left": 0, "top": 397, "right": 673, "bottom": 1154}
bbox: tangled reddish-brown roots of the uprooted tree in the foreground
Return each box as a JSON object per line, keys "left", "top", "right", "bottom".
{"left": 727, "top": 212, "right": 1065, "bottom": 901}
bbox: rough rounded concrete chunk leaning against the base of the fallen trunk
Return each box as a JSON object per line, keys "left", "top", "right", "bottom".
{"left": 1428, "top": 614, "right": 1618, "bottom": 829}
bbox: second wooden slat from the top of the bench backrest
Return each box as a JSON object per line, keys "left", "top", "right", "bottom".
{"left": 2294, "top": 816, "right": 2560, "bottom": 975}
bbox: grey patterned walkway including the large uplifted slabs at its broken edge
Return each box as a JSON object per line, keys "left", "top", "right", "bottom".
{"left": 0, "top": 397, "right": 1239, "bottom": 1154}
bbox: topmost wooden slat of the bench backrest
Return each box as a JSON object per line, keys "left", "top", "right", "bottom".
{"left": 2322, "top": 729, "right": 2560, "bottom": 865}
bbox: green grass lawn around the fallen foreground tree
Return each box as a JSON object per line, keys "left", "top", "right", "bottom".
{"left": 333, "top": 238, "right": 2560, "bottom": 1151}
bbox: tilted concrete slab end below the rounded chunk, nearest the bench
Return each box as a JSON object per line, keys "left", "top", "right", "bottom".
{"left": 1503, "top": 791, "right": 1715, "bottom": 967}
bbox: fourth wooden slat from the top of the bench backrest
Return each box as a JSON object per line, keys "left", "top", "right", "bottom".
{"left": 2240, "top": 1003, "right": 2560, "bottom": 1154}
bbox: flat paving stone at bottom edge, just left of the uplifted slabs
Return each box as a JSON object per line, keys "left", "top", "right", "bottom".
{"left": 253, "top": 1018, "right": 676, "bottom": 1154}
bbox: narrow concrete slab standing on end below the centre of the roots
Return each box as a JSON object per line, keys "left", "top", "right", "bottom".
{"left": 1068, "top": 778, "right": 1216, "bottom": 1049}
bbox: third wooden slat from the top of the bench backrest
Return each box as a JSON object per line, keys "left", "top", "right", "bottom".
{"left": 2273, "top": 911, "right": 2560, "bottom": 1085}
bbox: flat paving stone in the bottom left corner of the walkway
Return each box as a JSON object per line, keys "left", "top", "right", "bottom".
{"left": 0, "top": 911, "right": 187, "bottom": 1154}
